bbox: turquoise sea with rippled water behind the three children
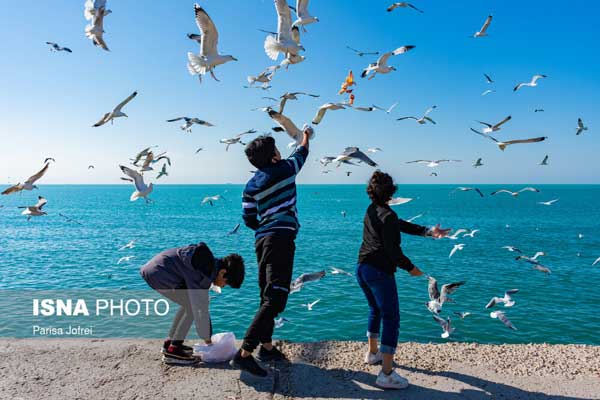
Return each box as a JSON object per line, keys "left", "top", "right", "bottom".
{"left": 0, "top": 185, "right": 600, "bottom": 345}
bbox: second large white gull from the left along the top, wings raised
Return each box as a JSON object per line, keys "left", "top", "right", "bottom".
{"left": 188, "top": 4, "right": 237, "bottom": 82}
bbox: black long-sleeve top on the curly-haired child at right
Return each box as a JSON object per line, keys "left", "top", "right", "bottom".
{"left": 358, "top": 203, "right": 429, "bottom": 274}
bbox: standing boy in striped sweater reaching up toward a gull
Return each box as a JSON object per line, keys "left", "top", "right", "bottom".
{"left": 231, "top": 127, "right": 313, "bottom": 377}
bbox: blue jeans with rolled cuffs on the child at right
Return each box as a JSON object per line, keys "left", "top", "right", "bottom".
{"left": 356, "top": 264, "right": 400, "bottom": 354}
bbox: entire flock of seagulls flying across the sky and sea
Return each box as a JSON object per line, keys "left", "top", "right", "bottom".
{"left": 1, "top": 0, "right": 600, "bottom": 338}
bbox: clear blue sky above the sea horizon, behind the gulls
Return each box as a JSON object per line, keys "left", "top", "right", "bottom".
{"left": 0, "top": 0, "right": 600, "bottom": 183}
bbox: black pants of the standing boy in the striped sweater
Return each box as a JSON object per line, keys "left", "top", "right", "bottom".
{"left": 242, "top": 232, "right": 296, "bottom": 352}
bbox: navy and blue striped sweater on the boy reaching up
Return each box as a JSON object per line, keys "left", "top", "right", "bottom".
{"left": 242, "top": 146, "right": 308, "bottom": 239}
